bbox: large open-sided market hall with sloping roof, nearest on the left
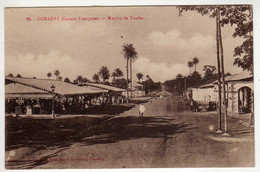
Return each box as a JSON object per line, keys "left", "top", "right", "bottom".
{"left": 5, "top": 77, "right": 108, "bottom": 115}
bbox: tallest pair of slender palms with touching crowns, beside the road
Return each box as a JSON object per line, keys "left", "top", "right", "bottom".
{"left": 122, "top": 43, "right": 138, "bottom": 97}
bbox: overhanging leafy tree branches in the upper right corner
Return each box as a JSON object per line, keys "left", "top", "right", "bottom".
{"left": 177, "top": 5, "right": 253, "bottom": 73}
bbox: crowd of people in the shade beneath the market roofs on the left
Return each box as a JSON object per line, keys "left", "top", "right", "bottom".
{"left": 5, "top": 94, "right": 129, "bottom": 115}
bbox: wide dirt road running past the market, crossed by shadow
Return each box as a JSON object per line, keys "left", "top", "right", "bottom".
{"left": 5, "top": 98, "right": 254, "bottom": 169}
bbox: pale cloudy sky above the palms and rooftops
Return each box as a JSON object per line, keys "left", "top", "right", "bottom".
{"left": 5, "top": 6, "right": 246, "bottom": 82}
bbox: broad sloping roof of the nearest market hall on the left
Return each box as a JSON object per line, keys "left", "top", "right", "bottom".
{"left": 5, "top": 77, "right": 108, "bottom": 95}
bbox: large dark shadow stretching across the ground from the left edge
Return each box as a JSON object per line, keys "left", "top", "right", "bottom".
{"left": 6, "top": 113, "right": 192, "bottom": 169}
